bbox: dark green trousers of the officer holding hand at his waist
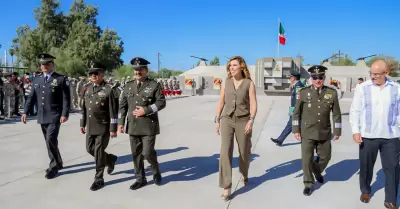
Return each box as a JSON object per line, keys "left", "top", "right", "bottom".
{"left": 129, "top": 135, "right": 160, "bottom": 182}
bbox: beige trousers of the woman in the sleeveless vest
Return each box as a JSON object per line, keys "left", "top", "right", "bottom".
{"left": 219, "top": 115, "right": 252, "bottom": 189}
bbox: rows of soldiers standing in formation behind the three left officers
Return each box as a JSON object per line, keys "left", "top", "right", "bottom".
{"left": 0, "top": 64, "right": 182, "bottom": 120}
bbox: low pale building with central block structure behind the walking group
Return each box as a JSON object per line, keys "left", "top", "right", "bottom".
{"left": 176, "top": 57, "right": 369, "bottom": 94}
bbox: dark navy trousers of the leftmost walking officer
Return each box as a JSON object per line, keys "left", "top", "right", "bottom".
{"left": 41, "top": 123, "right": 63, "bottom": 170}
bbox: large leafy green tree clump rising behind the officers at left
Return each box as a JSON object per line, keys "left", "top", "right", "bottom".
{"left": 12, "top": 0, "right": 123, "bottom": 76}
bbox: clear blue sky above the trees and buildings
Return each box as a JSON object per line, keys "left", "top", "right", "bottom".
{"left": 0, "top": 0, "right": 400, "bottom": 71}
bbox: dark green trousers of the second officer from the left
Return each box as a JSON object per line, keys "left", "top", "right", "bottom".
{"left": 86, "top": 131, "right": 113, "bottom": 180}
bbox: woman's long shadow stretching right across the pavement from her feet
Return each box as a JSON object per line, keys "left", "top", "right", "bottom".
{"left": 232, "top": 159, "right": 301, "bottom": 198}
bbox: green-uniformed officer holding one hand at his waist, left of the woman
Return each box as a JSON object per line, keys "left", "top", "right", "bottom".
{"left": 118, "top": 57, "right": 166, "bottom": 190}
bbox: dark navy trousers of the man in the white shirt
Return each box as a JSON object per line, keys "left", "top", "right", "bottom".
{"left": 360, "top": 138, "right": 400, "bottom": 204}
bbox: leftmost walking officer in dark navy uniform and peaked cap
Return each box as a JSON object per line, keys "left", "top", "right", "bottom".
{"left": 21, "top": 54, "right": 71, "bottom": 179}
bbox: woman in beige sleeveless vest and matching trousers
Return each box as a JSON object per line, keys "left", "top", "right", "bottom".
{"left": 215, "top": 56, "right": 257, "bottom": 201}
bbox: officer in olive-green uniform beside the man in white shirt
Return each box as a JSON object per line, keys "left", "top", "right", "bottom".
{"left": 292, "top": 65, "right": 342, "bottom": 196}
